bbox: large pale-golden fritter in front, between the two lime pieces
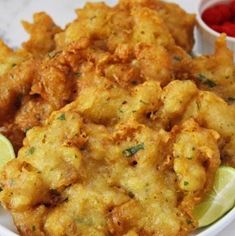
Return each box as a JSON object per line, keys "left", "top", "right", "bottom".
{"left": 1, "top": 76, "right": 220, "bottom": 236}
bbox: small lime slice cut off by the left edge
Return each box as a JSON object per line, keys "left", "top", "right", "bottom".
{"left": 0, "top": 134, "right": 15, "bottom": 172}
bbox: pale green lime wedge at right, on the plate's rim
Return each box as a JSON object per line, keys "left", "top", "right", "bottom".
{"left": 193, "top": 166, "right": 235, "bottom": 227}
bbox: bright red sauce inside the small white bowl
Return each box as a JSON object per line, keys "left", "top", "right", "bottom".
{"left": 202, "top": 0, "right": 235, "bottom": 37}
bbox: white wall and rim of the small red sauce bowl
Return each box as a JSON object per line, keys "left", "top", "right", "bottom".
{"left": 197, "top": 0, "right": 235, "bottom": 58}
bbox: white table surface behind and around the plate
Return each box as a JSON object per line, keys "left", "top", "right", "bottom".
{"left": 0, "top": 0, "right": 235, "bottom": 236}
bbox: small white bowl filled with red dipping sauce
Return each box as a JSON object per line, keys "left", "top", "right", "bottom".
{"left": 197, "top": 0, "right": 235, "bottom": 57}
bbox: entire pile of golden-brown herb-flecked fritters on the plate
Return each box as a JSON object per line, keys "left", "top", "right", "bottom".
{"left": 0, "top": 0, "right": 235, "bottom": 236}
